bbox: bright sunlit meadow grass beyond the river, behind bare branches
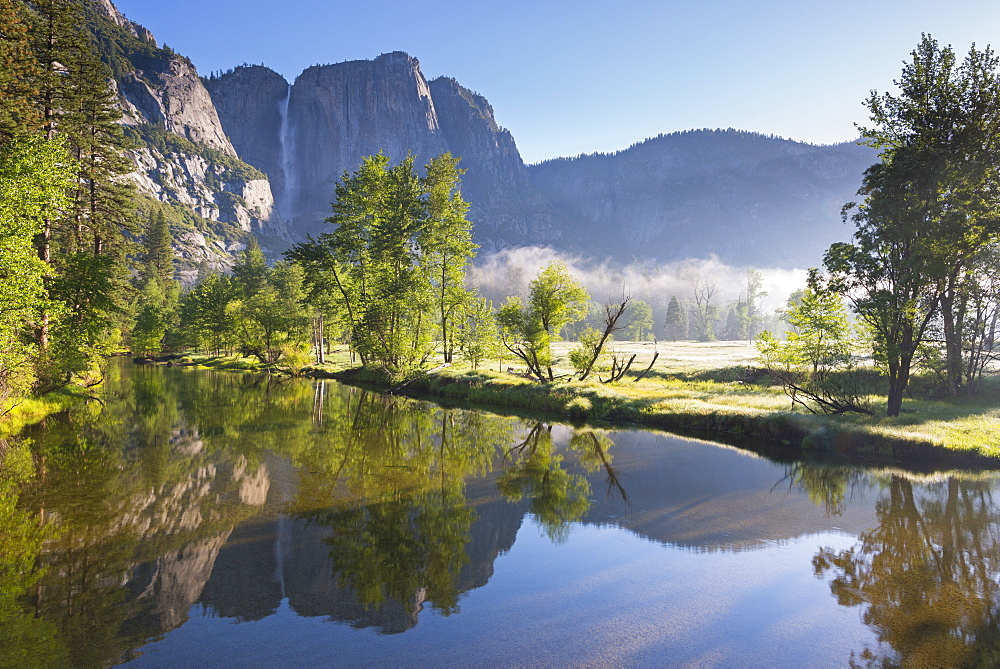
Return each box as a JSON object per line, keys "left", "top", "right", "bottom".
{"left": 180, "top": 342, "right": 1000, "bottom": 457}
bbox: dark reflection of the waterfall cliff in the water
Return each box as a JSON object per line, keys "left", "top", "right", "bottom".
{"left": 193, "top": 480, "right": 524, "bottom": 634}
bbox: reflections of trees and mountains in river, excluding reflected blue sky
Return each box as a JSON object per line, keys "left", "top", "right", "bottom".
{"left": 0, "top": 364, "right": 1000, "bottom": 665}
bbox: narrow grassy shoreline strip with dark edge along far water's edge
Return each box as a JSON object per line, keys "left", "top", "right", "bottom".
{"left": 129, "top": 355, "right": 1000, "bottom": 470}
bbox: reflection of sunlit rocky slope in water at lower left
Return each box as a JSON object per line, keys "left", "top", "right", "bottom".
{"left": 32, "top": 446, "right": 270, "bottom": 666}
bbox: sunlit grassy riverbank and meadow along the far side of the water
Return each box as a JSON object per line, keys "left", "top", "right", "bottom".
{"left": 172, "top": 343, "right": 1000, "bottom": 467}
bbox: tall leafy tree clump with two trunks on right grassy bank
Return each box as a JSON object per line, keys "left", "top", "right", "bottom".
{"left": 824, "top": 35, "right": 1000, "bottom": 416}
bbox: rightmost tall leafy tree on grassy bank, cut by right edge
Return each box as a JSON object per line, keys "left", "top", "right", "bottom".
{"left": 862, "top": 35, "right": 1000, "bottom": 395}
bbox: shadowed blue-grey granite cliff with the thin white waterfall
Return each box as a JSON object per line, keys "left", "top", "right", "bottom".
{"left": 207, "top": 52, "right": 561, "bottom": 247}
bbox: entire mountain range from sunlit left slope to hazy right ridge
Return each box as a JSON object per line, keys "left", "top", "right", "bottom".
{"left": 92, "top": 0, "right": 875, "bottom": 275}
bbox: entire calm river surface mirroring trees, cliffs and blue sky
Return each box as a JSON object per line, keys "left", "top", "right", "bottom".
{"left": 0, "top": 363, "right": 1000, "bottom": 666}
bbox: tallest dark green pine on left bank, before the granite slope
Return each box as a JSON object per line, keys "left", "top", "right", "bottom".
{"left": 32, "top": 0, "right": 135, "bottom": 389}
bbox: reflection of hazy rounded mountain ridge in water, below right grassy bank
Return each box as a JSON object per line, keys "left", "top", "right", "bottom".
{"left": 584, "top": 432, "right": 873, "bottom": 550}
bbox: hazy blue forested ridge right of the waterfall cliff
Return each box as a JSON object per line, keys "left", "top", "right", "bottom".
{"left": 529, "top": 130, "right": 875, "bottom": 267}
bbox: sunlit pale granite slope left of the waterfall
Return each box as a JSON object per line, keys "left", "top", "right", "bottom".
{"left": 88, "top": 0, "right": 287, "bottom": 280}
